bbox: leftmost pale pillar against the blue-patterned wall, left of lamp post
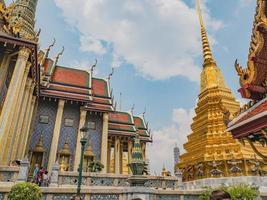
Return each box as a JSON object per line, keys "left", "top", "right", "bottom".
{"left": 47, "top": 100, "right": 65, "bottom": 173}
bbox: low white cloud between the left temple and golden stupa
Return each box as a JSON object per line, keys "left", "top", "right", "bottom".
{"left": 148, "top": 108, "right": 195, "bottom": 174}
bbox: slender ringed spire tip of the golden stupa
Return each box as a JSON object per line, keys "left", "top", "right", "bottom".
{"left": 197, "top": 0, "right": 215, "bottom": 67}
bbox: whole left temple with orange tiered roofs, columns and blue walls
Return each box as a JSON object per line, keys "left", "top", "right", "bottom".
{"left": 0, "top": 0, "right": 152, "bottom": 174}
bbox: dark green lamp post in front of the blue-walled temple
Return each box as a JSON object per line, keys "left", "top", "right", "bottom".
{"left": 77, "top": 126, "right": 89, "bottom": 196}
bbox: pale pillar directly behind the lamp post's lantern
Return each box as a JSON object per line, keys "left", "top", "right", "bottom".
{"left": 74, "top": 110, "right": 87, "bottom": 172}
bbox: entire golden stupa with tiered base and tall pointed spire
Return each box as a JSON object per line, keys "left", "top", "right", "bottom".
{"left": 176, "top": 1, "right": 267, "bottom": 181}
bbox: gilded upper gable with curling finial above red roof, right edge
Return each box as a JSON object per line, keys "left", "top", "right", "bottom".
{"left": 235, "top": 0, "right": 267, "bottom": 100}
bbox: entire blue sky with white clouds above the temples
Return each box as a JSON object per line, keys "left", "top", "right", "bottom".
{"left": 7, "top": 0, "right": 255, "bottom": 173}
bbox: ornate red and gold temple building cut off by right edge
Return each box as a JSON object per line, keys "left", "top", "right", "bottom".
{"left": 228, "top": 0, "right": 267, "bottom": 162}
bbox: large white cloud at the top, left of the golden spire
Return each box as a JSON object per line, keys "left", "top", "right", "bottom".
{"left": 54, "top": 0, "right": 222, "bottom": 81}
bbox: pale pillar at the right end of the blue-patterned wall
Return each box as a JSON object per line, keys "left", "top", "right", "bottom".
{"left": 101, "top": 113, "right": 108, "bottom": 173}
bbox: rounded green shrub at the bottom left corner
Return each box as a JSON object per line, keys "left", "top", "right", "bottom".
{"left": 8, "top": 182, "right": 42, "bottom": 200}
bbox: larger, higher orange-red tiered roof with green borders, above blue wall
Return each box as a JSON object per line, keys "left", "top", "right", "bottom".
{"left": 40, "top": 53, "right": 114, "bottom": 112}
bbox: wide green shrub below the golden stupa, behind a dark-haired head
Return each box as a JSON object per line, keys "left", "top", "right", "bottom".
{"left": 199, "top": 184, "right": 259, "bottom": 200}
